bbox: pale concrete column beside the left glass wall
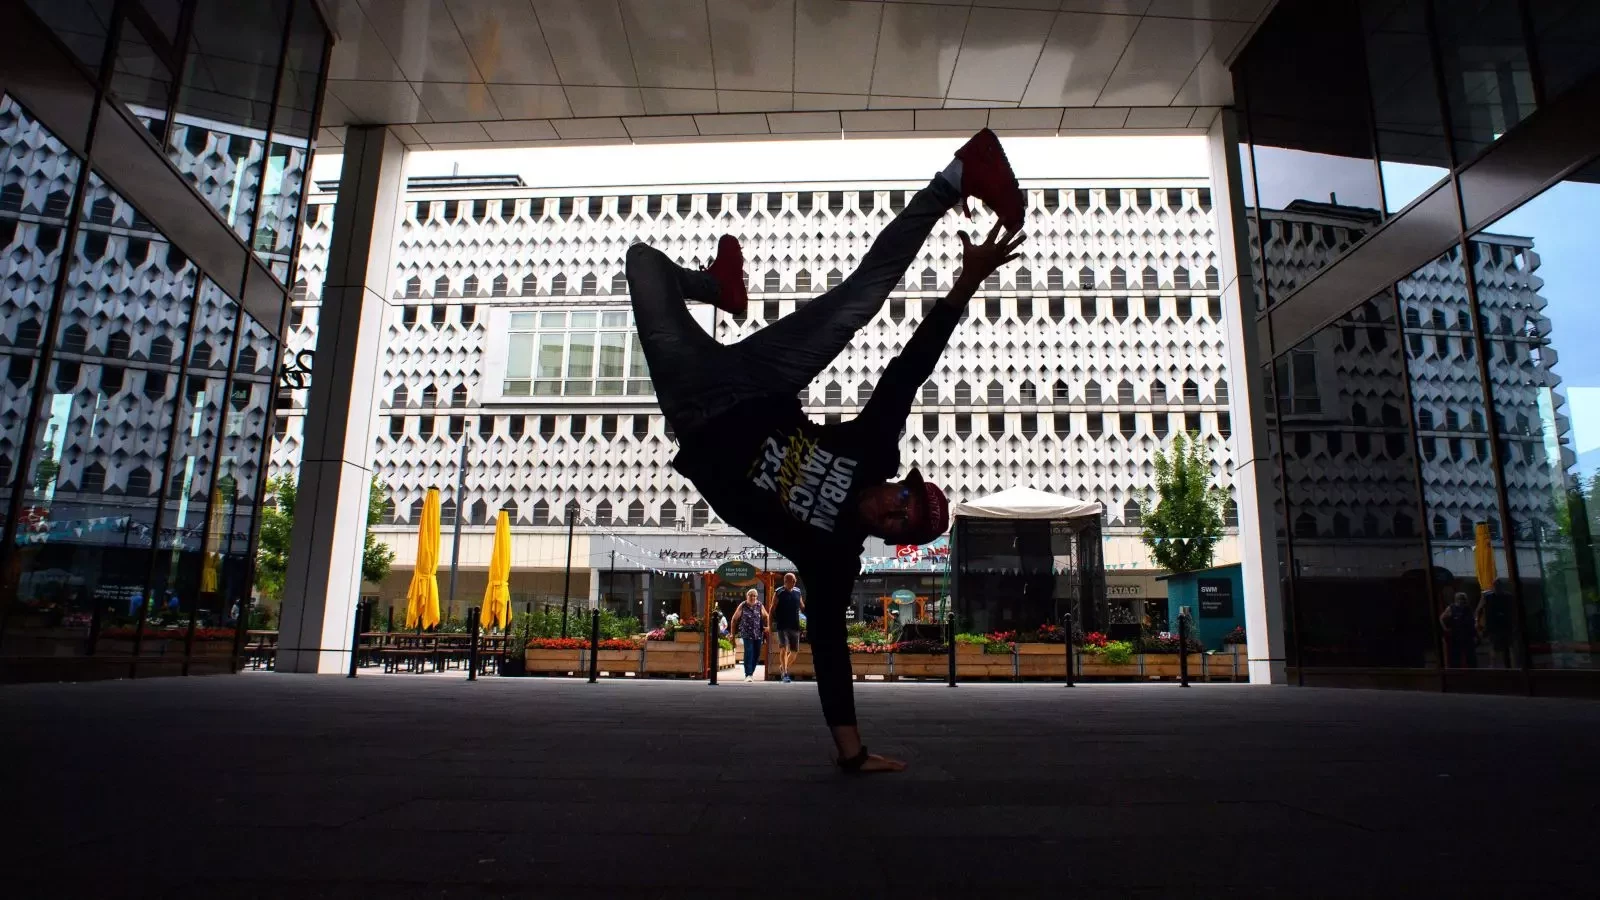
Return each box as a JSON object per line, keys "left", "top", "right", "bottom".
{"left": 277, "top": 125, "right": 405, "bottom": 673}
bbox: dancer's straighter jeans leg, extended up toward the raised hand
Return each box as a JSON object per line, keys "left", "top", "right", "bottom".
{"left": 736, "top": 175, "right": 962, "bottom": 394}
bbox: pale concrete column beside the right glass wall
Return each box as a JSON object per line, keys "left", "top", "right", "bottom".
{"left": 1206, "top": 110, "right": 1288, "bottom": 684}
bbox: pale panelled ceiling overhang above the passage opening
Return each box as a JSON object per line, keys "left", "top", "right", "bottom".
{"left": 320, "top": 0, "right": 1272, "bottom": 149}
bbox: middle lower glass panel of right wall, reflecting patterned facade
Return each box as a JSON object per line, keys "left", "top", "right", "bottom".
{"left": 1395, "top": 248, "right": 1520, "bottom": 668}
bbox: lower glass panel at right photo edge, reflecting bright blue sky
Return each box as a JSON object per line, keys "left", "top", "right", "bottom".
{"left": 1470, "top": 165, "right": 1600, "bottom": 668}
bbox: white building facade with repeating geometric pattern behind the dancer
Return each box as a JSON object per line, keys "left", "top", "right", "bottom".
{"left": 272, "top": 179, "right": 1232, "bottom": 565}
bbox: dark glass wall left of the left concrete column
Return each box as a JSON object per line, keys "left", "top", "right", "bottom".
{"left": 0, "top": 0, "right": 328, "bottom": 677}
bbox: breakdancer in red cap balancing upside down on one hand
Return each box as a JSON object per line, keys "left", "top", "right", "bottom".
{"left": 627, "top": 128, "right": 1022, "bottom": 772}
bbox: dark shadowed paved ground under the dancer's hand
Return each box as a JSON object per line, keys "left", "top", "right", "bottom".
{"left": 0, "top": 673, "right": 1600, "bottom": 900}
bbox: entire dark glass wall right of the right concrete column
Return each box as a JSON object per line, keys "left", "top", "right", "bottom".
{"left": 1234, "top": 0, "right": 1600, "bottom": 687}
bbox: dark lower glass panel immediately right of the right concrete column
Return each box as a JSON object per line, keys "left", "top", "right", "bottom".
{"left": 1275, "top": 295, "right": 1437, "bottom": 668}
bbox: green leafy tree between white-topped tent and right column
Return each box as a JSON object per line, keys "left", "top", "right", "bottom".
{"left": 1139, "top": 434, "right": 1227, "bottom": 572}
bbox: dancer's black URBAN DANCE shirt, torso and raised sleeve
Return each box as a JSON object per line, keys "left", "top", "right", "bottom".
{"left": 672, "top": 303, "right": 962, "bottom": 573}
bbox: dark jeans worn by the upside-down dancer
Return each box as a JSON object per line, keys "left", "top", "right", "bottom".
{"left": 627, "top": 176, "right": 962, "bottom": 434}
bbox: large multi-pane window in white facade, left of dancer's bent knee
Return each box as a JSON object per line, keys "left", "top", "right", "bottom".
{"left": 504, "top": 309, "right": 651, "bottom": 397}
